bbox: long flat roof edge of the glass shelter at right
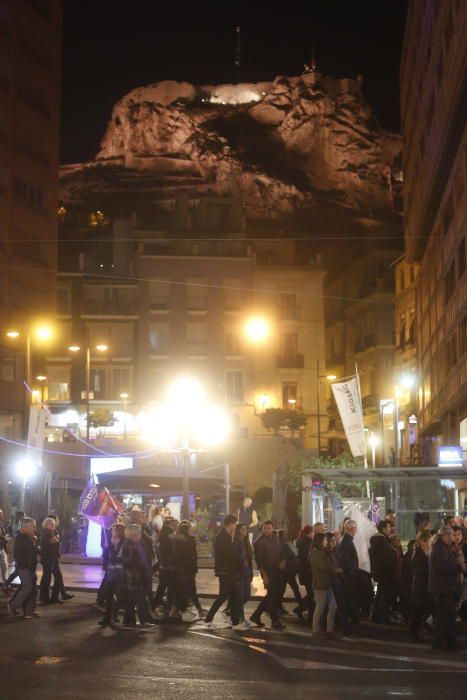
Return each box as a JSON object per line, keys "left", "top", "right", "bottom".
{"left": 304, "top": 466, "right": 467, "bottom": 481}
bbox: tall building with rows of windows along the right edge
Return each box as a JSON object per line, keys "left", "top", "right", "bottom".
{"left": 401, "top": 0, "right": 467, "bottom": 464}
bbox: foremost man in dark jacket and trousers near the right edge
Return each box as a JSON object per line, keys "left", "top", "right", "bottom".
{"left": 429, "top": 525, "right": 464, "bottom": 650}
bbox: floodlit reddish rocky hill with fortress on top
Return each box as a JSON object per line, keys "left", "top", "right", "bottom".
{"left": 61, "top": 73, "right": 401, "bottom": 227}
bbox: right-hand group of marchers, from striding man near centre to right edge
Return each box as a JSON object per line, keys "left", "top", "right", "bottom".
{"left": 206, "top": 511, "right": 467, "bottom": 650}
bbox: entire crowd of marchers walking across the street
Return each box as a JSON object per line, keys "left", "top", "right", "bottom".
{"left": 0, "top": 504, "right": 467, "bottom": 649}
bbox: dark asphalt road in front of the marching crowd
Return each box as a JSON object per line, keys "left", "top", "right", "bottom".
{"left": 0, "top": 593, "right": 467, "bottom": 700}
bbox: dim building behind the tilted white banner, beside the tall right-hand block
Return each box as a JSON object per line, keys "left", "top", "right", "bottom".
{"left": 325, "top": 243, "right": 400, "bottom": 465}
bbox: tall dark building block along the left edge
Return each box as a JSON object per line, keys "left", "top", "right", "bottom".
{"left": 0, "top": 0, "right": 61, "bottom": 438}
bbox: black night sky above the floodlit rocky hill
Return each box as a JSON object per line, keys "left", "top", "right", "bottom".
{"left": 61, "top": 0, "right": 407, "bottom": 163}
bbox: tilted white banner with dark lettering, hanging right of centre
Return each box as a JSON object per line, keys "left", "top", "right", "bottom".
{"left": 331, "top": 376, "right": 366, "bottom": 457}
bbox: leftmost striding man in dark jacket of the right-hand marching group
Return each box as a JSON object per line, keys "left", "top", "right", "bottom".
{"left": 206, "top": 515, "right": 241, "bottom": 627}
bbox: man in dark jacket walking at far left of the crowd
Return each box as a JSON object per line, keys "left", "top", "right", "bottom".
{"left": 8, "top": 518, "right": 40, "bottom": 620}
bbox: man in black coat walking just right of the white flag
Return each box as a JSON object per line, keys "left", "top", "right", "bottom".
{"left": 370, "top": 520, "right": 396, "bottom": 623}
